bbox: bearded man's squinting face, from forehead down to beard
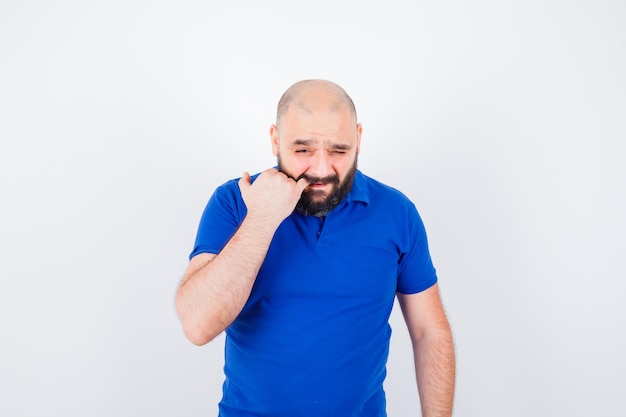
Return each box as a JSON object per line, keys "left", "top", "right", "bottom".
{"left": 270, "top": 103, "right": 362, "bottom": 216}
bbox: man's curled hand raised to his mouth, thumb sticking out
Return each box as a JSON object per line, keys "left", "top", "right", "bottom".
{"left": 239, "top": 168, "right": 309, "bottom": 227}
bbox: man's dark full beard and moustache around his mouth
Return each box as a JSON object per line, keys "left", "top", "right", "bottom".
{"left": 278, "top": 156, "right": 357, "bottom": 217}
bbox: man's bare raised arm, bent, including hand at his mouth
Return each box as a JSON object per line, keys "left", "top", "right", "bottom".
{"left": 176, "top": 168, "right": 308, "bottom": 345}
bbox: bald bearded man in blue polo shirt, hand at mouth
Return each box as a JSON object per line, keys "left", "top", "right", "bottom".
{"left": 176, "top": 80, "right": 455, "bottom": 417}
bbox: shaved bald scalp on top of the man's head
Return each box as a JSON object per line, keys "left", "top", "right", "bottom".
{"left": 276, "top": 80, "right": 356, "bottom": 126}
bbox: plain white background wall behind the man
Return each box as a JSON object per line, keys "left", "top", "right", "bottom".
{"left": 0, "top": 0, "right": 626, "bottom": 417}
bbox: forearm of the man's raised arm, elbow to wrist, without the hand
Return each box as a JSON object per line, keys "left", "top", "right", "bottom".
{"left": 176, "top": 217, "right": 276, "bottom": 345}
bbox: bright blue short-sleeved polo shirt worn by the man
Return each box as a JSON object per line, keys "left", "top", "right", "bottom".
{"left": 190, "top": 171, "right": 437, "bottom": 417}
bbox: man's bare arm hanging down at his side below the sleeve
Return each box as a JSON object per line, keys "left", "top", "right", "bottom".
{"left": 397, "top": 284, "right": 455, "bottom": 417}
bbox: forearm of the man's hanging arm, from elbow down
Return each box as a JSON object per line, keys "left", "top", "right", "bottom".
{"left": 413, "top": 323, "right": 455, "bottom": 417}
